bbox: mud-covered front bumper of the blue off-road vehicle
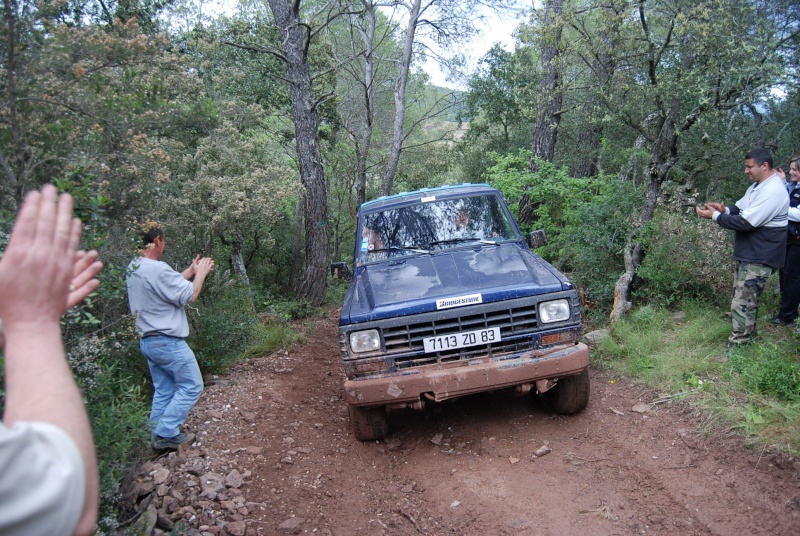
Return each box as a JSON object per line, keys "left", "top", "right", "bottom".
{"left": 344, "top": 343, "right": 589, "bottom": 406}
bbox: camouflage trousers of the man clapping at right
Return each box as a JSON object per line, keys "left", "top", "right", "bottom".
{"left": 728, "top": 262, "right": 775, "bottom": 344}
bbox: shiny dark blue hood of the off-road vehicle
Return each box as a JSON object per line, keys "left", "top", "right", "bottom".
{"left": 340, "top": 243, "right": 572, "bottom": 324}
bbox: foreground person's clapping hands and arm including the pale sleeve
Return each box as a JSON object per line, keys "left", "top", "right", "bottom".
{"left": 0, "top": 185, "right": 102, "bottom": 535}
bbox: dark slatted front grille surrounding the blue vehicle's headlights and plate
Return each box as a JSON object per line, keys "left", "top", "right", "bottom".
{"left": 340, "top": 294, "right": 580, "bottom": 376}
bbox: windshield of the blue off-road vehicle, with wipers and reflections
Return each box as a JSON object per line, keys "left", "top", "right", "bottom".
{"left": 358, "top": 195, "right": 520, "bottom": 263}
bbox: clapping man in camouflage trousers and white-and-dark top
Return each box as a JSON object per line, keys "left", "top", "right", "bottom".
{"left": 696, "top": 149, "right": 789, "bottom": 345}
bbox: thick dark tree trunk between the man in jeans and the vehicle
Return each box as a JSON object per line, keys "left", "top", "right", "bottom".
{"left": 269, "top": 0, "right": 329, "bottom": 305}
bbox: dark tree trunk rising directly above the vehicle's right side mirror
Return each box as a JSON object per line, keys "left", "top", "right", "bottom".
{"left": 517, "top": 0, "right": 564, "bottom": 225}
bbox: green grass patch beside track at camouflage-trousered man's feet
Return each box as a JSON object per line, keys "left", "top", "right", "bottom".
{"left": 592, "top": 302, "right": 800, "bottom": 454}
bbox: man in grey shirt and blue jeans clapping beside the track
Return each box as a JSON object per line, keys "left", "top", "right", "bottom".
{"left": 126, "top": 222, "right": 214, "bottom": 450}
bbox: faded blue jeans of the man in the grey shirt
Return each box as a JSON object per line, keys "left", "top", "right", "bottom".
{"left": 139, "top": 335, "right": 203, "bottom": 437}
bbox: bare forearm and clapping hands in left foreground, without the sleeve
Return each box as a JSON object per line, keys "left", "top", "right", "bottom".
{"left": 0, "top": 185, "right": 102, "bottom": 534}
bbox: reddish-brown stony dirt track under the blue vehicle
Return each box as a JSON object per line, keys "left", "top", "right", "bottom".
{"left": 124, "top": 317, "right": 800, "bottom": 536}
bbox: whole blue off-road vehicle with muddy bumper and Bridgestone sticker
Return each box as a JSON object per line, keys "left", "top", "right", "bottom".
{"left": 339, "top": 184, "right": 589, "bottom": 441}
